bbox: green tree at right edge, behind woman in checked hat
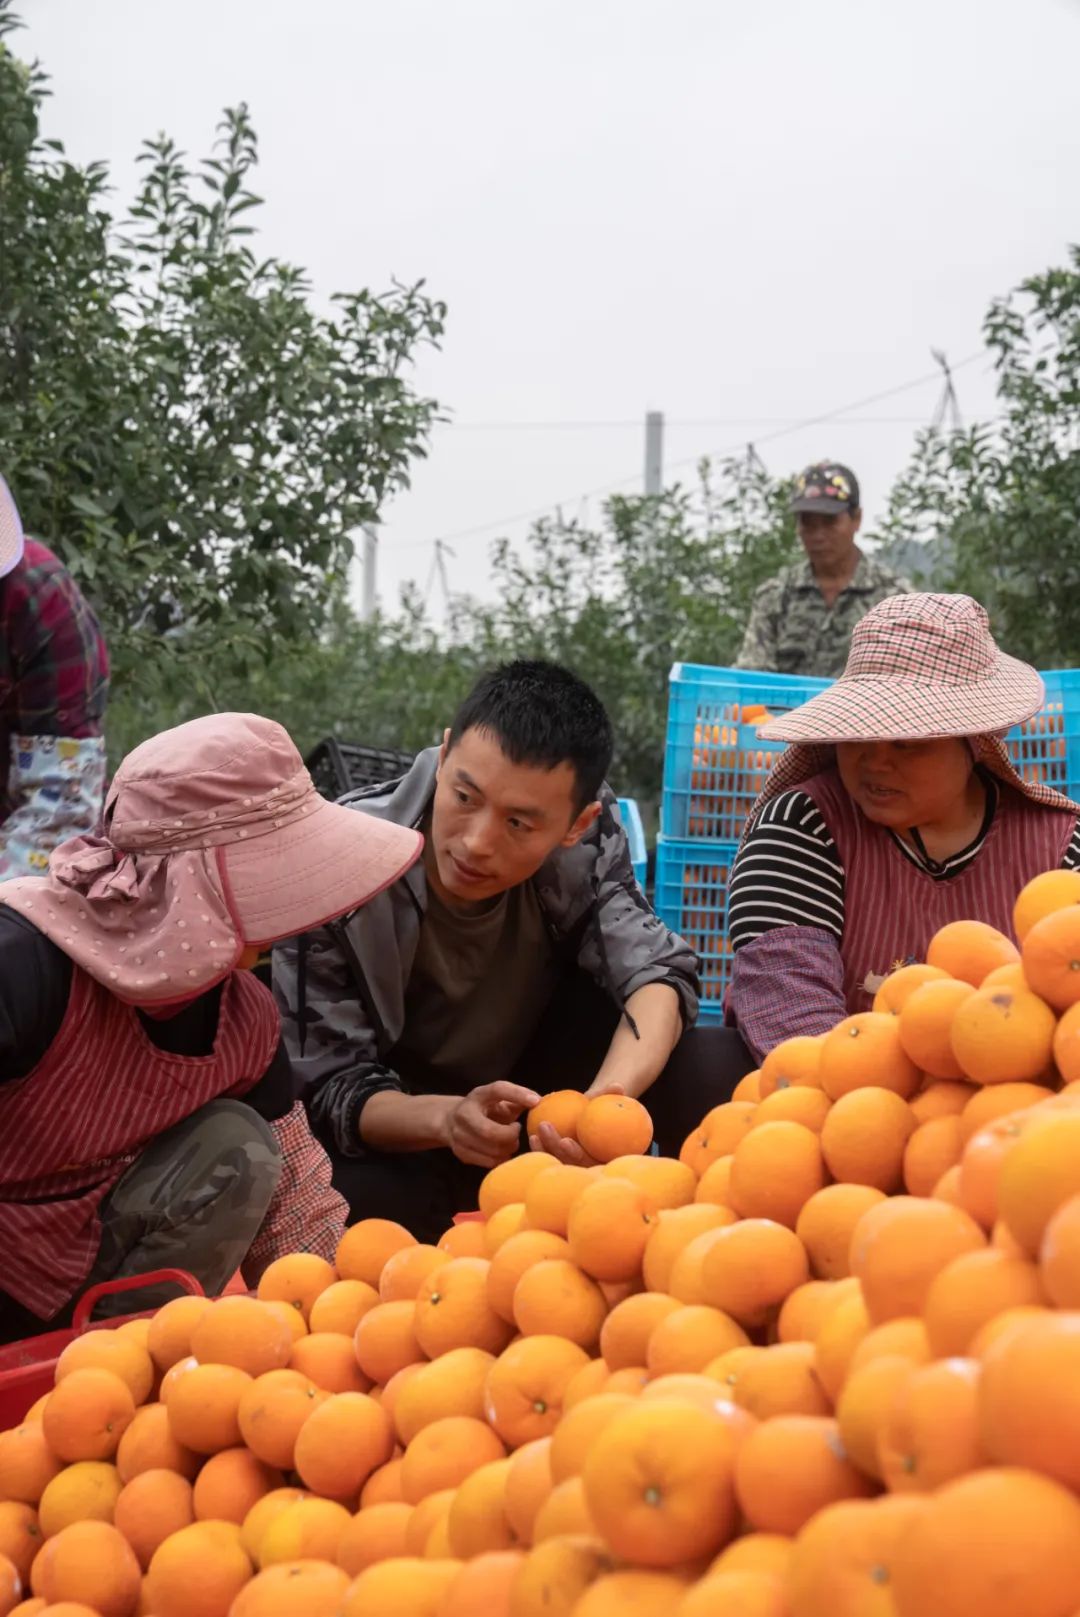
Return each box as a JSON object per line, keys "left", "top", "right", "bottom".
{"left": 883, "top": 247, "right": 1080, "bottom": 668}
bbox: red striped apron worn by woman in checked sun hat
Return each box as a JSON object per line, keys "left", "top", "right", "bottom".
{"left": 800, "top": 770, "right": 1077, "bottom": 1014}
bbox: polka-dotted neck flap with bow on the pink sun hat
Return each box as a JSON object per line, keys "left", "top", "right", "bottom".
{"left": 0, "top": 836, "right": 244, "bottom": 1006}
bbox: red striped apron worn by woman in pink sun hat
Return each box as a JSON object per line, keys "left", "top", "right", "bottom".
{"left": 0, "top": 967, "right": 280, "bottom": 1319}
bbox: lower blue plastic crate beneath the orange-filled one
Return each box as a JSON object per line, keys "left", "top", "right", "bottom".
{"left": 653, "top": 836, "right": 737, "bottom": 1022}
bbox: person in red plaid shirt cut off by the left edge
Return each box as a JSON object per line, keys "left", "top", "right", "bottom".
{"left": 0, "top": 477, "right": 108, "bottom": 881}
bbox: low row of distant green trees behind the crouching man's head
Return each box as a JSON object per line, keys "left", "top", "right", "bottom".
{"left": 113, "top": 462, "right": 797, "bottom": 812}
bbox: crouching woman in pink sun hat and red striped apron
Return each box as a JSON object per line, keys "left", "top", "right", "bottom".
{"left": 0, "top": 713, "right": 422, "bottom": 1340}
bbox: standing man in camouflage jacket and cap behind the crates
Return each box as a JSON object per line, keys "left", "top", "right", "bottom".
{"left": 736, "top": 461, "right": 910, "bottom": 679}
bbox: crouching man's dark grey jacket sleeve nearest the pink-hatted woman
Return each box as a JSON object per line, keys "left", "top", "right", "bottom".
{"left": 273, "top": 928, "right": 403, "bottom": 1156}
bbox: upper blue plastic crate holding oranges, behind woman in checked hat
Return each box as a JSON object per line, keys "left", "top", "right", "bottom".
{"left": 661, "top": 663, "right": 1080, "bottom": 842}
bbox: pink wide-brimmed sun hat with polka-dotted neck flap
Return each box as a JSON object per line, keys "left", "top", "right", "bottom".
{"left": 0, "top": 713, "right": 424, "bottom": 1004}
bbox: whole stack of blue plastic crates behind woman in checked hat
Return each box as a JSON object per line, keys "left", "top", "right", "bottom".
{"left": 655, "top": 663, "right": 1080, "bottom": 1022}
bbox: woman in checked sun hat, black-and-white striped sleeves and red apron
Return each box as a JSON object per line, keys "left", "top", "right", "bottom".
{"left": 728, "top": 593, "right": 1080, "bottom": 1059}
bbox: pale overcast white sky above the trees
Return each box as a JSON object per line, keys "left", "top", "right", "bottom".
{"left": 13, "top": 0, "right": 1080, "bottom": 608}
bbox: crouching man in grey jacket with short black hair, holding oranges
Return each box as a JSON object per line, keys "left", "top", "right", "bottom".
{"left": 273, "top": 661, "right": 707, "bottom": 1239}
